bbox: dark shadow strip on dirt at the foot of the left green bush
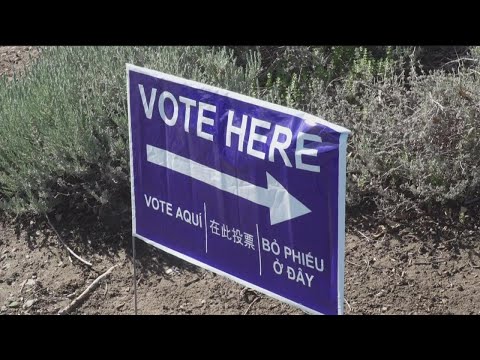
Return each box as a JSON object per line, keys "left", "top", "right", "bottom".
{"left": 1, "top": 213, "right": 201, "bottom": 276}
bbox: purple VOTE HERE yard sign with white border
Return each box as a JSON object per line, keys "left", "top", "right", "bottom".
{"left": 127, "top": 64, "right": 349, "bottom": 314}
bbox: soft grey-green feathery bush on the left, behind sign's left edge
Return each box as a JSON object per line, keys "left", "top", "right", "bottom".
{"left": 0, "top": 47, "right": 260, "bottom": 214}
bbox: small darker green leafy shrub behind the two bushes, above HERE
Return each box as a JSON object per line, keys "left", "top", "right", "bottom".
{"left": 260, "top": 46, "right": 405, "bottom": 108}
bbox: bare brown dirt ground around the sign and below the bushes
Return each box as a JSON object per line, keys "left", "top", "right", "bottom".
{"left": 0, "top": 47, "right": 480, "bottom": 315}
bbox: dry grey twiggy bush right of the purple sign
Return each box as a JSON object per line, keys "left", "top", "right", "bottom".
{"left": 265, "top": 49, "right": 480, "bottom": 216}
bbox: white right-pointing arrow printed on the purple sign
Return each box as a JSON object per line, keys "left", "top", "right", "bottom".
{"left": 147, "top": 144, "right": 311, "bottom": 225}
